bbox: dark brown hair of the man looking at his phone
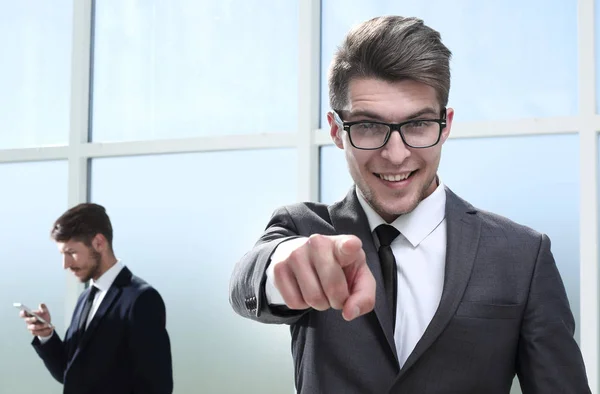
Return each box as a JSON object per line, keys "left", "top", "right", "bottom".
{"left": 50, "top": 203, "right": 113, "bottom": 249}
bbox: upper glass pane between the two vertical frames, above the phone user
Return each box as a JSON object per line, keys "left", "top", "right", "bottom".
{"left": 92, "top": 0, "right": 298, "bottom": 142}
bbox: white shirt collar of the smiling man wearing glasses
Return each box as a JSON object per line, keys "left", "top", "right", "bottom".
{"left": 356, "top": 180, "right": 446, "bottom": 247}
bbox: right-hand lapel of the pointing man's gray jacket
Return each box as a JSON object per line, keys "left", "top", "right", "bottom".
{"left": 398, "top": 188, "right": 481, "bottom": 378}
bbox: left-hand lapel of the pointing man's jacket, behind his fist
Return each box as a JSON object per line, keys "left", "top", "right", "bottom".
{"left": 329, "top": 187, "right": 398, "bottom": 360}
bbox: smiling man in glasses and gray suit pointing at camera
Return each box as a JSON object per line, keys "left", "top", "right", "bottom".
{"left": 230, "top": 16, "right": 590, "bottom": 394}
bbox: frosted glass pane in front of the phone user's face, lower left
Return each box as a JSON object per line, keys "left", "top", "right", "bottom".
{"left": 0, "top": 161, "right": 72, "bottom": 394}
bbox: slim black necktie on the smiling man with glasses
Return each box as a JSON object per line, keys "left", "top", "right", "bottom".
{"left": 375, "top": 224, "right": 400, "bottom": 330}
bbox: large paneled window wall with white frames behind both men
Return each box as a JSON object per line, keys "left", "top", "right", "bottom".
{"left": 0, "top": 0, "right": 600, "bottom": 394}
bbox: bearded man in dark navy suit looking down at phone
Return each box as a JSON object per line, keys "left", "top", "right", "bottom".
{"left": 21, "top": 203, "right": 173, "bottom": 394}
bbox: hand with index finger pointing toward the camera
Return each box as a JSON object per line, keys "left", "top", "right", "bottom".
{"left": 271, "top": 234, "right": 375, "bottom": 320}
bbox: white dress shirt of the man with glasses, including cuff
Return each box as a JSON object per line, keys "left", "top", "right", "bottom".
{"left": 265, "top": 181, "right": 446, "bottom": 367}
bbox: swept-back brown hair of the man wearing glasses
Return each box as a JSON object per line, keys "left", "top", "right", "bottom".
{"left": 329, "top": 16, "right": 452, "bottom": 110}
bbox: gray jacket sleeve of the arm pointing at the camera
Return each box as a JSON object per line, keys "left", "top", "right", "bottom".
{"left": 229, "top": 207, "right": 308, "bottom": 324}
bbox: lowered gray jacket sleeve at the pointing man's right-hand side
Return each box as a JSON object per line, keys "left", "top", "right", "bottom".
{"left": 517, "top": 235, "right": 591, "bottom": 394}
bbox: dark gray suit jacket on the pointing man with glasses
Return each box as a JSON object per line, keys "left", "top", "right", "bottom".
{"left": 230, "top": 188, "right": 590, "bottom": 394}
